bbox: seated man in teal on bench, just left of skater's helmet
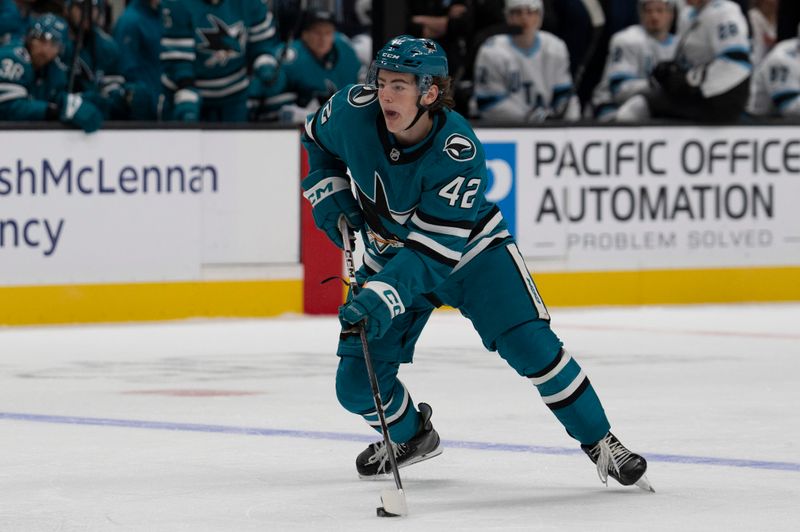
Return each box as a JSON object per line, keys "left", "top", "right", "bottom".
{"left": 248, "top": 9, "right": 361, "bottom": 124}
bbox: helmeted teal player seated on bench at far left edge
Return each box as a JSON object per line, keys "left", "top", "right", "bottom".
{"left": 0, "top": 14, "right": 103, "bottom": 133}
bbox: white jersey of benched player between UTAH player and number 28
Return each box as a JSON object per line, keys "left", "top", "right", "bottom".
{"left": 592, "top": 25, "right": 677, "bottom": 117}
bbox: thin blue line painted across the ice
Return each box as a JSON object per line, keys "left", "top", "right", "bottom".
{"left": 0, "top": 412, "right": 800, "bottom": 472}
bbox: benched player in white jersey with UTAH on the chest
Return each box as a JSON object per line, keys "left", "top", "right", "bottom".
{"left": 475, "top": 0, "right": 580, "bottom": 123}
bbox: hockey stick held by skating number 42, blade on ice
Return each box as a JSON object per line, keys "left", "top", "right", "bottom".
{"left": 339, "top": 216, "right": 408, "bottom": 517}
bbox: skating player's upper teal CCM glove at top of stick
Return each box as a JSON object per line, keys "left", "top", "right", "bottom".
{"left": 303, "top": 177, "right": 364, "bottom": 249}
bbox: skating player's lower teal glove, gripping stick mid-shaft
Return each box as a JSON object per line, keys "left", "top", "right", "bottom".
{"left": 339, "top": 282, "right": 404, "bottom": 340}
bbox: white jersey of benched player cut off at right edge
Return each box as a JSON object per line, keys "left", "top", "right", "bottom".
{"left": 747, "top": 39, "right": 800, "bottom": 117}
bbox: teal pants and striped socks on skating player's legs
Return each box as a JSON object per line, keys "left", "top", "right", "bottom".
{"left": 336, "top": 241, "right": 610, "bottom": 444}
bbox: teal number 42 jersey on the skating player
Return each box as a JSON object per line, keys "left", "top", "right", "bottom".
{"left": 303, "top": 85, "right": 511, "bottom": 306}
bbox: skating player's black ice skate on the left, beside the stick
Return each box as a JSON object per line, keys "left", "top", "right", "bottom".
{"left": 356, "top": 403, "right": 442, "bottom": 479}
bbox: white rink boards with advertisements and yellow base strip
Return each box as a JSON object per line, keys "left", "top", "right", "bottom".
{"left": 0, "top": 126, "right": 800, "bottom": 324}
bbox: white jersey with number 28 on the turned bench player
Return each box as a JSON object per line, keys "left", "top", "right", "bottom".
{"left": 675, "top": 0, "right": 753, "bottom": 98}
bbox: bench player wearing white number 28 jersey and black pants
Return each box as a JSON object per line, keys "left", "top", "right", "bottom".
{"left": 617, "top": 0, "right": 753, "bottom": 122}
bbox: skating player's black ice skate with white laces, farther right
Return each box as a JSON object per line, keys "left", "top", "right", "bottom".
{"left": 581, "top": 432, "right": 656, "bottom": 492}
